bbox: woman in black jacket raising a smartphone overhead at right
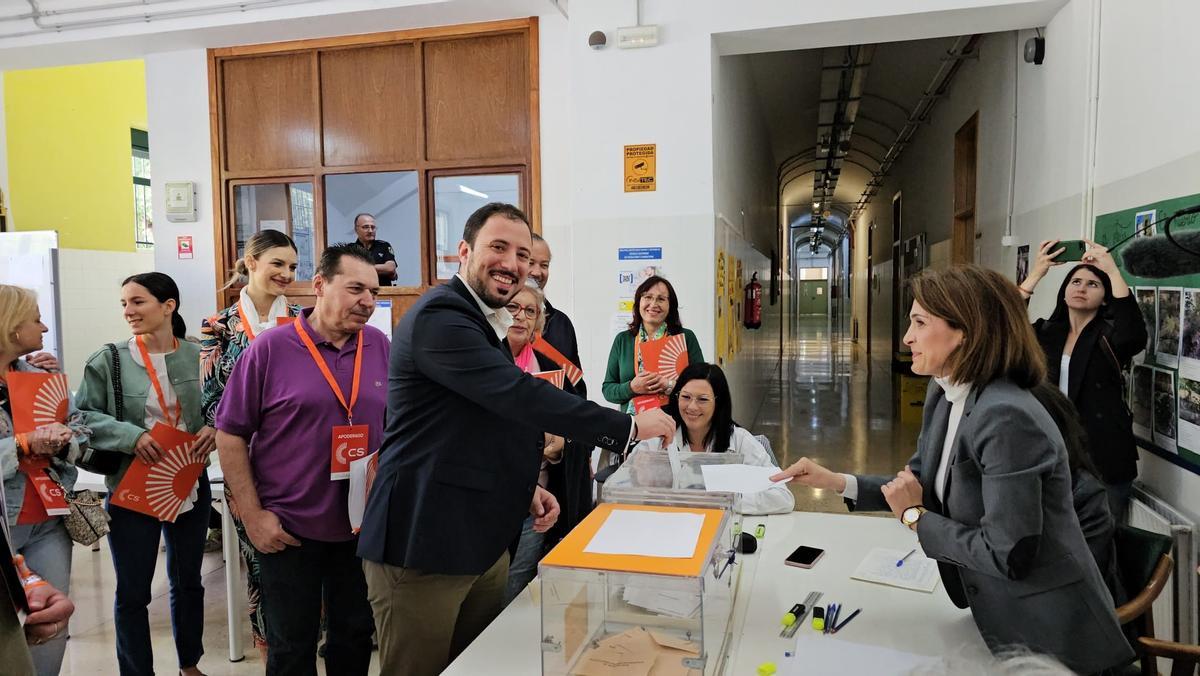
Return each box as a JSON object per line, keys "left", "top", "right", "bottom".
{"left": 1018, "top": 240, "right": 1147, "bottom": 524}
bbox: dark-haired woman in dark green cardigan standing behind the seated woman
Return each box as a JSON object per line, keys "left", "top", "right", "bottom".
{"left": 601, "top": 275, "right": 704, "bottom": 413}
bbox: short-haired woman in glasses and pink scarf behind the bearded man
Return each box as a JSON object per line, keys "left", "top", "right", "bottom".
{"left": 504, "top": 280, "right": 590, "bottom": 605}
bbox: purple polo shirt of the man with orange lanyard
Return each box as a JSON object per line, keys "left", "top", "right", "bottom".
{"left": 216, "top": 307, "right": 389, "bottom": 542}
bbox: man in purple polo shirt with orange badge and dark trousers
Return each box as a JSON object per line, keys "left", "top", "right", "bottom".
{"left": 216, "top": 245, "right": 389, "bottom": 676}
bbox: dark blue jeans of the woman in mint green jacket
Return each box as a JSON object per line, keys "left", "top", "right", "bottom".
{"left": 104, "top": 471, "right": 212, "bottom": 676}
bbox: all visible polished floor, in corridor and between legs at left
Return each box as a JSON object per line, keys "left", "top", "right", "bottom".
{"left": 51, "top": 309, "right": 902, "bottom": 676}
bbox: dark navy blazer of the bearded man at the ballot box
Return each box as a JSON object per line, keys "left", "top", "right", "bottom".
{"left": 359, "top": 277, "right": 631, "bottom": 575}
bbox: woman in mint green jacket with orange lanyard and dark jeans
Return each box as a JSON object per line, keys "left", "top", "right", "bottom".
{"left": 77, "top": 273, "right": 216, "bottom": 676}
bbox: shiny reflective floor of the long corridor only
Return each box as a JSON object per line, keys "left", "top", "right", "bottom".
{"left": 750, "top": 316, "right": 920, "bottom": 513}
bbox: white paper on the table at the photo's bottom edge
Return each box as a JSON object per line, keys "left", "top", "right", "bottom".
{"left": 782, "top": 633, "right": 937, "bottom": 676}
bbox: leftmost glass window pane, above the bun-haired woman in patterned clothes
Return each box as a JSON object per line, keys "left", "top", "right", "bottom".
{"left": 233, "top": 183, "right": 313, "bottom": 280}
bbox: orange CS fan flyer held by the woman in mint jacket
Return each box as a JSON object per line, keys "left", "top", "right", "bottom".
{"left": 112, "top": 423, "right": 204, "bottom": 522}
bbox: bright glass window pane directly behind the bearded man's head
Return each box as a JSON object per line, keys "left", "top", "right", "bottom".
{"left": 433, "top": 174, "right": 521, "bottom": 280}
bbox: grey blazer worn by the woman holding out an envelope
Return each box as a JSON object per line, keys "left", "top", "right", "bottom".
{"left": 853, "top": 379, "right": 1133, "bottom": 674}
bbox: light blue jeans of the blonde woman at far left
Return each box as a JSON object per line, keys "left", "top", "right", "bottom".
{"left": 11, "top": 516, "right": 71, "bottom": 676}
